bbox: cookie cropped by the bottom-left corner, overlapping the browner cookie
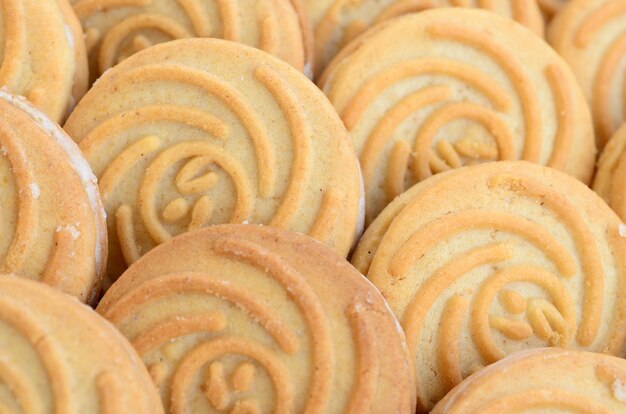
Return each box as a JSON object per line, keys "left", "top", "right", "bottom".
{"left": 0, "top": 275, "right": 163, "bottom": 414}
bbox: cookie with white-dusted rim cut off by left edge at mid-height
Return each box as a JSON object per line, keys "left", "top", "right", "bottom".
{"left": 0, "top": 89, "right": 107, "bottom": 303}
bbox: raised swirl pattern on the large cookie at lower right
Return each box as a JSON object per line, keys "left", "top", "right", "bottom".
{"left": 357, "top": 167, "right": 626, "bottom": 410}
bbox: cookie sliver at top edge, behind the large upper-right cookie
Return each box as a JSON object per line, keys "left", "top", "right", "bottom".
{"left": 303, "top": 0, "right": 544, "bottom": 74}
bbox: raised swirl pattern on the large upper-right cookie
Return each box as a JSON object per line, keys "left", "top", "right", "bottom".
{"left": 322, "top": 21, "right": 578, "bottom": 220}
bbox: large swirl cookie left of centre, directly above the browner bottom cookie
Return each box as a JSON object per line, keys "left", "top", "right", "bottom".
{"left": 65, "top": 39, "right": 364, "bottom": 279}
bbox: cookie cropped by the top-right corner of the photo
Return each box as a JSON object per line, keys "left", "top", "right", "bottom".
{"left": 548, "top": 0, "right": 626, "bottom": 148}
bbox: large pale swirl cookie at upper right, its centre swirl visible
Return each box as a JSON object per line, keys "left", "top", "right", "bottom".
{"left": 320, "top": 8, "right": 595, "bottom": 223}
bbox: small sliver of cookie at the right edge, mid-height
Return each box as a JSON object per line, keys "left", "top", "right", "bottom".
{"left": 593, "top": 124, "right": 626, "bottom": 220}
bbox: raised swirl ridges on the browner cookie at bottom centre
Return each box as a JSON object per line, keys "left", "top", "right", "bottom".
{"left": 99, "top": 236, "right": 378, "bottom": 414}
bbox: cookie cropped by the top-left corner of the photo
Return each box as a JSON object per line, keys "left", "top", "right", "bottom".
{"left": 0, "top": 0, "right": 88, "bottom": 122}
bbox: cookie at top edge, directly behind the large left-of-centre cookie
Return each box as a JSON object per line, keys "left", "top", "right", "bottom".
{"left": 72, "top": 0, "right": 313, "bottom": 80}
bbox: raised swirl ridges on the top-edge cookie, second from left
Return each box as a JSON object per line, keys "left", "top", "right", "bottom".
{"left": 73, "top": 0, "right": 294, "bottom": 73}
